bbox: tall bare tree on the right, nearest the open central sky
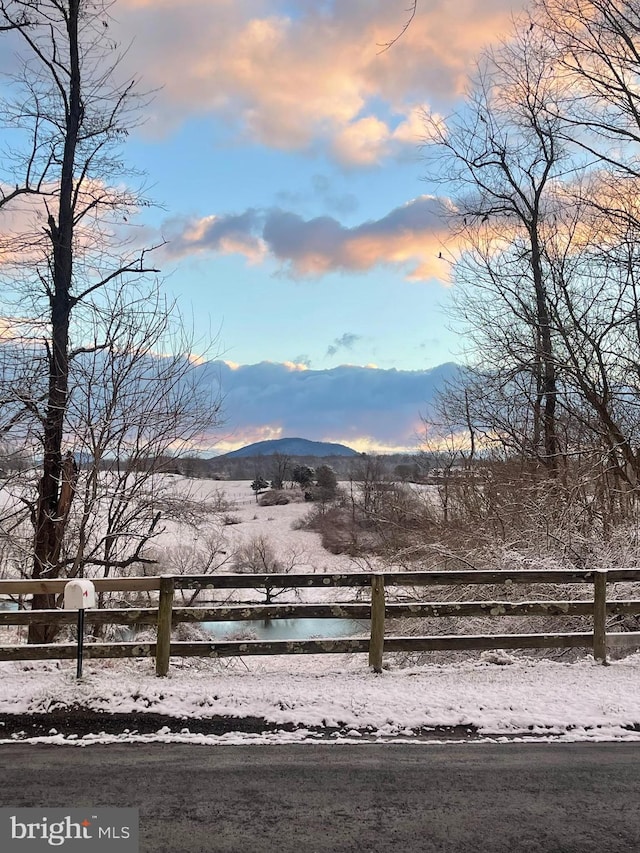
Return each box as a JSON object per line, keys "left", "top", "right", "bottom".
{"left": 427, "top": 21, "right": 567, "bottom": 477}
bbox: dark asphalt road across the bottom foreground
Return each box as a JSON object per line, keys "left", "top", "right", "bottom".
{"left": 0, "top": 743, "right": 640, "bottom": 853}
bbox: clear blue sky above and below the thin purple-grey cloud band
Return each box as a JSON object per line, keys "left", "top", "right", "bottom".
{"left": 132, "top": 116, "right": 451, "bottom": 369}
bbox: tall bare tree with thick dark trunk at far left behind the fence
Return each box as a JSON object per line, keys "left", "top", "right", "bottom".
{"left": 0, "top": 0, "right": 221, "bottom": 642}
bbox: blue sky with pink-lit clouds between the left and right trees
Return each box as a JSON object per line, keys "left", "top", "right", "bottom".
{"left": 3, "top": 0, "right": 523, "bottom": 450}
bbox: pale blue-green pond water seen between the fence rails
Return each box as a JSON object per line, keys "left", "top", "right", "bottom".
{"left": 202, "top": 619, "right": 371, "bottom": 640}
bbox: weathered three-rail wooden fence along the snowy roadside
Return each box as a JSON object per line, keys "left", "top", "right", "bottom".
{"left": 0, "top": 569, "right": 640, "bottom": 676}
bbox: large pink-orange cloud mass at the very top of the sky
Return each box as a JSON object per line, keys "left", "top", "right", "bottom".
{"left": 118, "top": 0, "right": 524, "bottom": 161}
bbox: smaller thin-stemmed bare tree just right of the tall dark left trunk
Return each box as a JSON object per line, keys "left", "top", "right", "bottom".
{"left": 64, "top": 287, "right": 220, "bottom": 575}
